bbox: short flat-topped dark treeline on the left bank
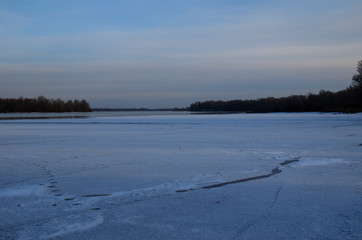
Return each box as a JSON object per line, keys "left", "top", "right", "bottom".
{"left": 0, "top": 96, "right": 92, "bottom": 113}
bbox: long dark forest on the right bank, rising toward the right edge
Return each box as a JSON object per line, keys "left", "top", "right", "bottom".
{"left": 189, "top": 60, "right": 362, "bottom": 113}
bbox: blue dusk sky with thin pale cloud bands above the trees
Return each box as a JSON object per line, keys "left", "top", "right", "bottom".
{"left": 0, "top": 0, "right": 362, "bottom": 108}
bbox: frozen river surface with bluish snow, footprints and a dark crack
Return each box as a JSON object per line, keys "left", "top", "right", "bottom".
{"left": 0, "top": 113, "right": 362, "bottom": 240}
